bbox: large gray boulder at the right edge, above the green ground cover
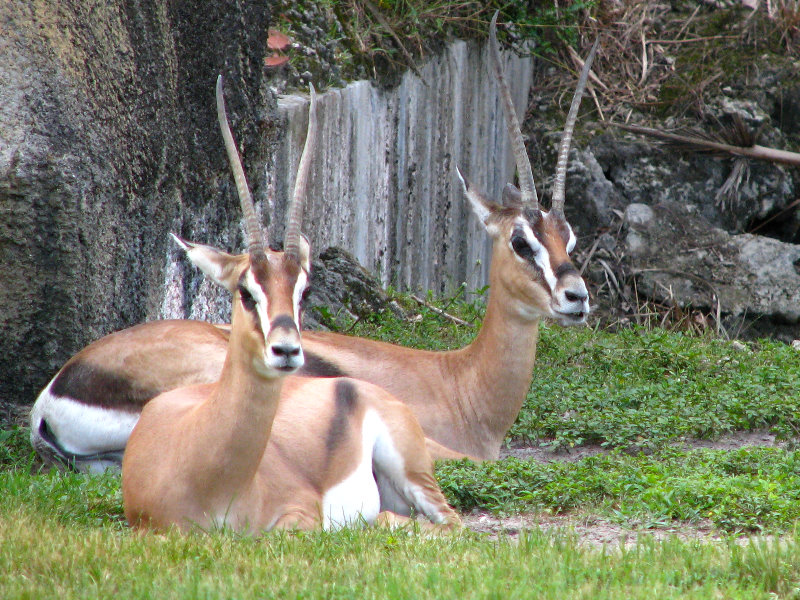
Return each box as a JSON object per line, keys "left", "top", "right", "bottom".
{"left": 626, "top": 203, "right": 800, "bottom": 343}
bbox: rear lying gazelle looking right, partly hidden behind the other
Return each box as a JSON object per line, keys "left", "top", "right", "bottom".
{"left": 31, "top": 15, "right": 596, "bottom": 468}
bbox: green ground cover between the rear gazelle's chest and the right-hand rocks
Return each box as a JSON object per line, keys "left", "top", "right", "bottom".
{"left": 511, "top": 328, "right": 800, "bottom": 450}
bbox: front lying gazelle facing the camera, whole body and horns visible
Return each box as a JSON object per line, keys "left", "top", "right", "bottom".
{"left": 122, "top": 77, "right": 459, "bottom": 533}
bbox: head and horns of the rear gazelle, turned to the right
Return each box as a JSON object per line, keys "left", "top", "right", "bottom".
{"left": 457, "top": 13, "right": 597, "bottom": 325}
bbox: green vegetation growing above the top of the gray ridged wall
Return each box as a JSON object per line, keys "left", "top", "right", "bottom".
{"left": 273, "top": 0, "right": 593, "bottom": 85}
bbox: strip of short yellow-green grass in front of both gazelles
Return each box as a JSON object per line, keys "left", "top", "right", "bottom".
{"left": 0, "top": 496, "right": 800, "bottom": 600}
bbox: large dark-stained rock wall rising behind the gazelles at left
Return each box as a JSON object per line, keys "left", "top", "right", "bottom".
{"left": 0, "top": 0, "right": 275, "bottom": 418}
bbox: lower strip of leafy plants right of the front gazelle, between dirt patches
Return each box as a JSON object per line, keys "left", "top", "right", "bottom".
{"left": 437, "top": 447, "right": 800, "bottom": 531}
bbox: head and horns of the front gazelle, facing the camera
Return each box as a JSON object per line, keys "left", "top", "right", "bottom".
{"left": 172, "top": 76, "right": 316, "bottom": 378}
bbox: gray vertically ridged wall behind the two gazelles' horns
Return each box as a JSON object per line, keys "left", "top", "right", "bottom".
{"left": 267, "top": 41, "right": 533, "bottom": 293}
